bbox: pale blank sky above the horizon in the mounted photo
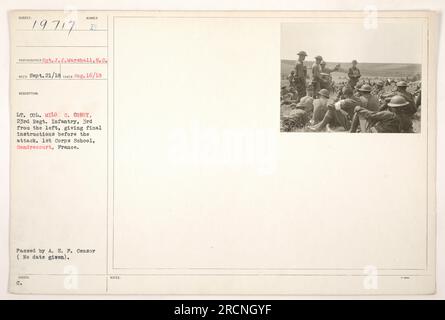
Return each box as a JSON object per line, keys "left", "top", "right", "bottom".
{"left": 281, "top": 22, "right": 422, "bottom": 63}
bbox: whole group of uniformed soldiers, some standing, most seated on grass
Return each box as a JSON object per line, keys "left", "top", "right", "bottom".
{"left": 281, "top": 51, "right": 421, "bottom": 133}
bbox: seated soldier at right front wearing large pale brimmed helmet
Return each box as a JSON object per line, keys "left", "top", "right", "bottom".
{"left": 351, "top": 96, "right": 413, "bottom": 133}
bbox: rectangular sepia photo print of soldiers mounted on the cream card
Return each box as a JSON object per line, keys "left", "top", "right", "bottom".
{"left": 280, "top": 22, "right": 423, "bottom": 133}
